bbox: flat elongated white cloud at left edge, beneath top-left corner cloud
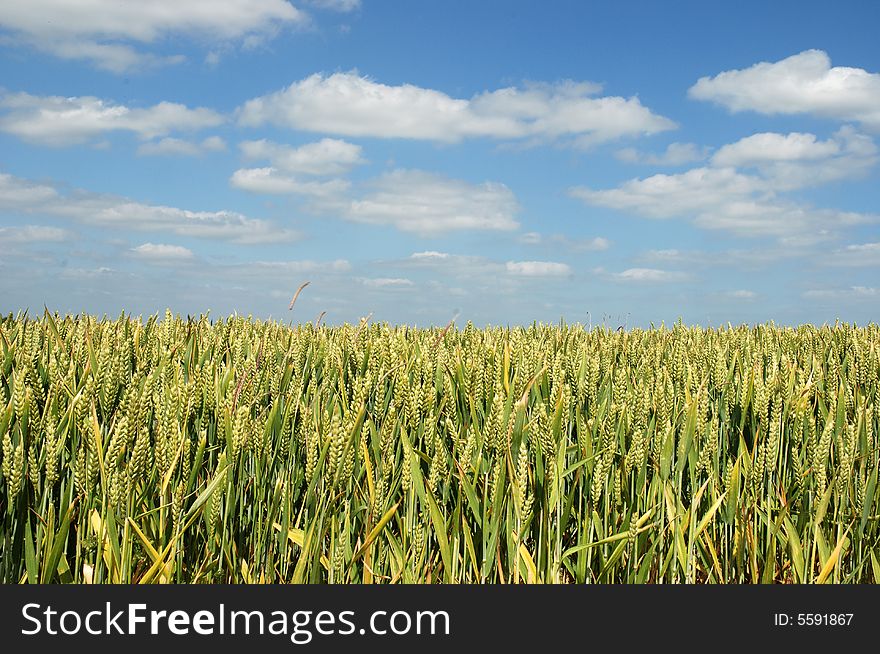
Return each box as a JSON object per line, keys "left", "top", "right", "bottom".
{"left": 0, "top": 93, "right": 224, "bottom": 146}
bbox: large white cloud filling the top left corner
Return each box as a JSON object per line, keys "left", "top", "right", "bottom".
{"left": 0, "top": 0, "right": 307, "bottom": 73}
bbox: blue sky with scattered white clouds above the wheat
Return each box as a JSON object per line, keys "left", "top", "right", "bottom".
{"left": 0, "top": 0, "right": 880, "bottom": 326}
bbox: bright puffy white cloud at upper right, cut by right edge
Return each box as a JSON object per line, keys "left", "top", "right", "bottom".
{"left": 688, "top": 50, "right": 880, "bottom": 130}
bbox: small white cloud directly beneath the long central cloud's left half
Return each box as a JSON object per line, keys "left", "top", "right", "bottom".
{"left": 239, "top": 139, "right": 366, "bottom": 175}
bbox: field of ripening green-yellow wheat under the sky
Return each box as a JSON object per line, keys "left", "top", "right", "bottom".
{"left": 0, "top": 312, "right": 880, "bottom": 584}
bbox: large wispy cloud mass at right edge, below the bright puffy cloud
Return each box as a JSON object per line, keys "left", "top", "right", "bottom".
{"left": 569, "top": 127, "right": 877, "bottom": 245}
